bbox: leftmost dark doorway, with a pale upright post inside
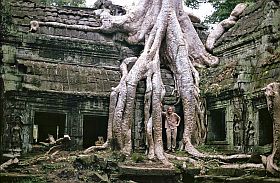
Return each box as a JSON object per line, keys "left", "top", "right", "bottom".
{"left": 34, "top": 112, "right": 66, "bottom": 142}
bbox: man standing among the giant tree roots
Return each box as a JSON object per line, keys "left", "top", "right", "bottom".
{"left": 163, "top": 106, "right": 181, "bottom": 152}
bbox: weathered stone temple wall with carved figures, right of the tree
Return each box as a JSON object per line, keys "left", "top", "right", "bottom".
{"left": 201, "top": 0, "right": 280, "bottom": 152}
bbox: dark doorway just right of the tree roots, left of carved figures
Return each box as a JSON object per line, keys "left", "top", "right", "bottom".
{"left": 207, "top": 109, "right": 226, "bottom": 141}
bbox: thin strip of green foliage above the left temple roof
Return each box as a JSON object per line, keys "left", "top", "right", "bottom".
{"left": 39, "top": 0, "right": 86, "bottom": 7}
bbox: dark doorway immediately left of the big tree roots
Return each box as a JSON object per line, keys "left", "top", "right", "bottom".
{"left": 83, "top": 115, "right": 108, "bottom": 148}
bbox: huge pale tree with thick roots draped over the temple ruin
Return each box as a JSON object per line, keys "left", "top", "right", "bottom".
{"left": 82, "top": 0, "right": 279, "bottom": 172}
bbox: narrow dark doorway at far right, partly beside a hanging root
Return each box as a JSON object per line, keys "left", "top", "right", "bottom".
{"left": 259, "top": 108, "right": 273, "bottom": 146}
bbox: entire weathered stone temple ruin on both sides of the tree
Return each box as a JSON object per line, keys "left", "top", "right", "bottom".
{"left": 0, "top": 0, "right": 280, "bottom": 163}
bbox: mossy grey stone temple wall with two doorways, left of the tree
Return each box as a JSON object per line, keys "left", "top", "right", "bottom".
{"left": 0, "top": 1, "right": 144, "bottom": 156}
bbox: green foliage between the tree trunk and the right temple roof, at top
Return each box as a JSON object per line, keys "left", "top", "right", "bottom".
{"left": 204, "top": 0, "right": 255, "bottom": 24}
